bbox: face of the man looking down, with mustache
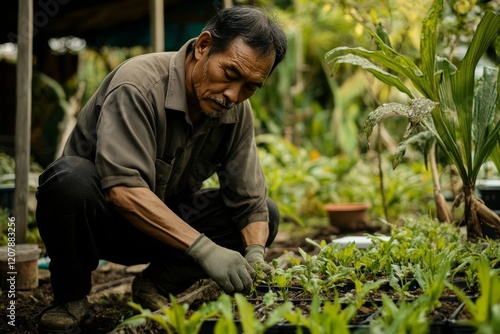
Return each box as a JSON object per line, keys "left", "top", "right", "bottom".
{"left": 192, "top": 36, "right": 274, "bottom": 116}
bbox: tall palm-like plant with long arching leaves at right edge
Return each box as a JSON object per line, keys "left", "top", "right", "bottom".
{"left": 326, "top": 0, "right": 500, "bottom": 241}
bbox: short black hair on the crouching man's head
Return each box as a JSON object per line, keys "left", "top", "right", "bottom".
{"left": 203, "top": 5, "right": 287, "bottom": 73}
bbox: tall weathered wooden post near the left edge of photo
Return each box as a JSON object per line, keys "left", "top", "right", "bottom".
{"left": 14, "top": 0, "right": 33, "bottom": 244}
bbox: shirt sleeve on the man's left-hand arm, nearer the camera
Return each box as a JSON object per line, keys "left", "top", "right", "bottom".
{"left": 96, "top": 84, "right": 156, "bottom": 191}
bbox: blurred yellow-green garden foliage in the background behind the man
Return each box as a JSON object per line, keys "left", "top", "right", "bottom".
{"left": 1, "top": 0, "right": 500, "bottom": 230}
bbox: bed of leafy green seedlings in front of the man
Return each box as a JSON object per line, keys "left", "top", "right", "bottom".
{"left": 116, "top": 217, "right": 500, "bottom": 334}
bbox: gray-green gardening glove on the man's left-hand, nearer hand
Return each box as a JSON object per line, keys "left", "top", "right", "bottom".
{"left": 186, "top": 234, "right": 255, "bottom": 294}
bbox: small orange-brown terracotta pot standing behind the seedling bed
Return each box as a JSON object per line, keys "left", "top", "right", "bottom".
{"left": 325, "top": 203, "right": 371, "bottom": 232}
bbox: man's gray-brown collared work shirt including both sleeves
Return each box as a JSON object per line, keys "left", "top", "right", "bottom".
{"left": 64, "top": 40, "right": 268, "bottom": 228}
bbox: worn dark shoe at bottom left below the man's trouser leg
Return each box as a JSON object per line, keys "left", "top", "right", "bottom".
{"left": 38, "top": 297, "right": 95, "bottom": 333}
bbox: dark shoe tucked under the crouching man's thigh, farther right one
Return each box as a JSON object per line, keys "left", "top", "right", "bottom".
{"left": 132, "top": 274, "right": 170, "bottom": 311}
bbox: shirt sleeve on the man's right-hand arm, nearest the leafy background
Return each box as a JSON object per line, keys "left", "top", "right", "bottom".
{"left": 218, "top": 101, "right": 269, "bottom": 229}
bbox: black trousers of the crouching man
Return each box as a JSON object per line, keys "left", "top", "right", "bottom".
{"left": 36, "top": 157, "right": 279, "bottom": 302}
